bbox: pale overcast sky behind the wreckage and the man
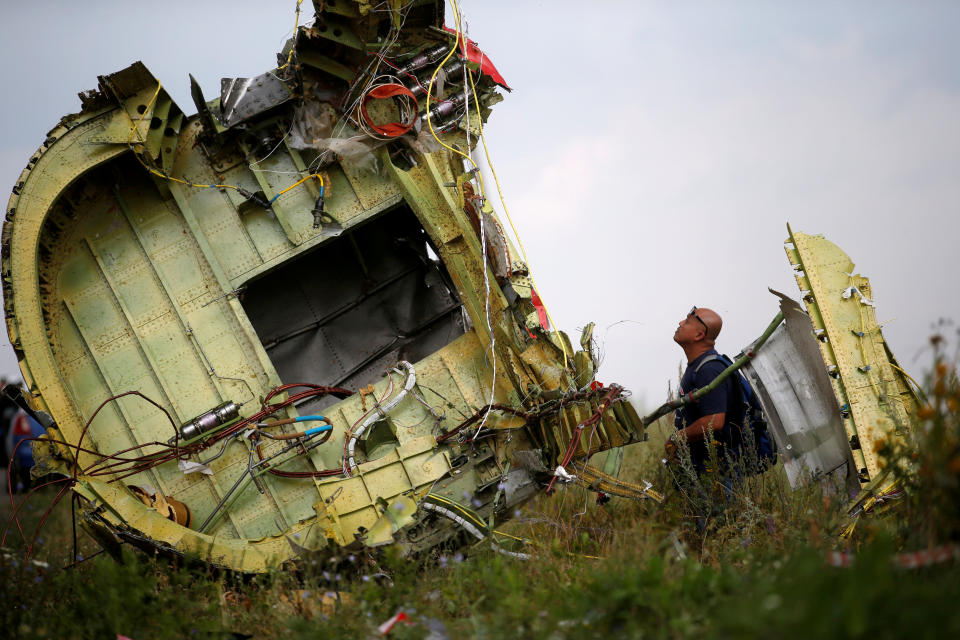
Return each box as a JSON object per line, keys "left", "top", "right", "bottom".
{"left": 0, "top": 0, "right": 960, "bottom": 406}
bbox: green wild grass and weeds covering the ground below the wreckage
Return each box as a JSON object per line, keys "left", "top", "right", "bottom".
{"left": 0, "top": 347, "right": 960, "bottom": 640}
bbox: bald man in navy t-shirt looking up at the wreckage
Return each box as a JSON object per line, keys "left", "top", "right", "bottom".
{"left": 664, "top": 307, "right": 745, "bottom": 473}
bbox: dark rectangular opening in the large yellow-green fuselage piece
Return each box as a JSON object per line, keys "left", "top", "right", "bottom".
{"left": 241, "top": 206, "right": 464, "bottom": 413}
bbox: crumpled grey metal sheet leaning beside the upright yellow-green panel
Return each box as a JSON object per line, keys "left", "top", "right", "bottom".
{"left": 743, "top": 290, "right": 856, "bottom": 488}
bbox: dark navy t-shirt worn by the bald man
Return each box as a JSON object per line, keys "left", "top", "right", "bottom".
{"left": 673, "top": 349, "right": 744, "bottom": 472}
